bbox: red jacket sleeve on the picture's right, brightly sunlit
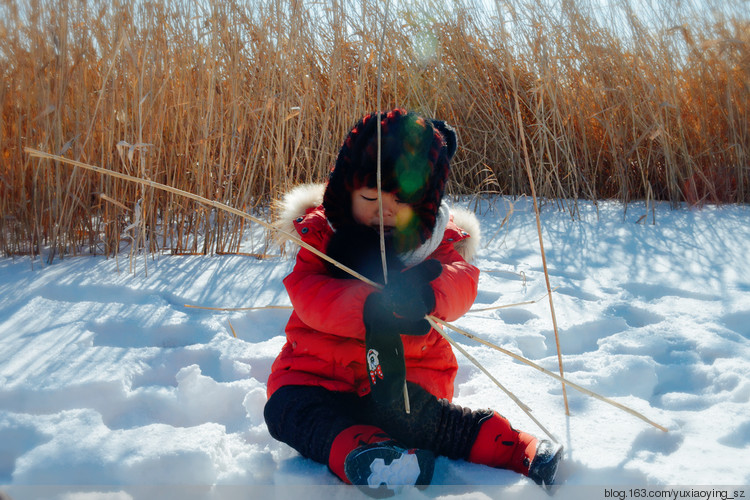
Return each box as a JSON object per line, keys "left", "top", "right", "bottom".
{"left": 431, "top": 244, "right": 479, "bottom": 321}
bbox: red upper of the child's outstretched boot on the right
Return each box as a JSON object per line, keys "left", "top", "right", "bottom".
{"left": 468, "top": 412, "right": 537, "bottom": 475}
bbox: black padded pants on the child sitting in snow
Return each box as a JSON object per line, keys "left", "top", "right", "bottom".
{"left": 264, "top": 382, "right": 492, "bottom": 464}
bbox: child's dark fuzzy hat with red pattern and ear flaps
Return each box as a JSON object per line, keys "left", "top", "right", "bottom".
{"left": 323, "top": 109, "right": 456, "bottom": 252}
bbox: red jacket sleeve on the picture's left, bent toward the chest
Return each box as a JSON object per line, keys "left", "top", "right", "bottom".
{"left": 284, "top": 248, "right": 375, "bottom": 341}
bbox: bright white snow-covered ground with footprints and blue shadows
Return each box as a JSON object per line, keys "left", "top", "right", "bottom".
{"left": 0, "top": 198, "right": 750, "bottom": 499}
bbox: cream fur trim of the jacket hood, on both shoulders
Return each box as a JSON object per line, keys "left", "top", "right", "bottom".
{"left": 275, "top": 184, "right": 481, "bottom": 262}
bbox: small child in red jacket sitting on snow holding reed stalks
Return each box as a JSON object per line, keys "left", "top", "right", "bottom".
{"left": 264, "top": 109, "right": 562, "bottom": 496}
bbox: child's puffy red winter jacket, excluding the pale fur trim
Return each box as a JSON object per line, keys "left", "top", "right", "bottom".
{"left": 268, "top": 186, "right": 479, "bottom": 400}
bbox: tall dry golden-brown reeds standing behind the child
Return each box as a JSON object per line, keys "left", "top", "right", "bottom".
{"left": 0, "top": 0, "right": 750, "bottom": 259}
